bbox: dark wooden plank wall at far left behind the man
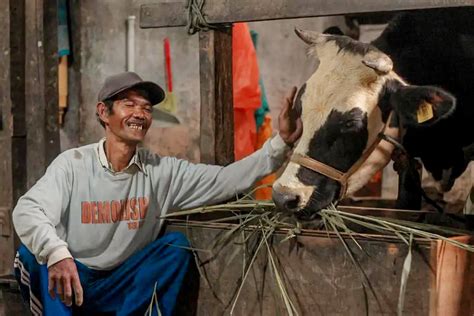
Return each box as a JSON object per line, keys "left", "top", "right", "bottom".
{"left": 0, "top": 0, "right": 60, "bottom": 276}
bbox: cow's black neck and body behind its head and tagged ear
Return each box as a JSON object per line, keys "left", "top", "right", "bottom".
{"left": 372, "top": 8, "right": 474, "bottom": 195}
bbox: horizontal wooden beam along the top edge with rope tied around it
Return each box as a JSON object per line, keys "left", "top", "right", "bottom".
{"left": 140, "top": 0, "right": 474, "bottom": 28}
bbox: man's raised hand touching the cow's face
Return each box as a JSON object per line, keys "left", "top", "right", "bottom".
{"left": 278, "top": 87, "right": 303, "bottom": 146}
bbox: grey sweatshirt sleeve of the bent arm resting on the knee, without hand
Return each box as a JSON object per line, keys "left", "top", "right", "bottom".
{"left": 13, "top": 155, "right": 72, "bottom": 266}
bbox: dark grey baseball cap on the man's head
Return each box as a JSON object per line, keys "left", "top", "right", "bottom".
{"left": 98, "top": 71, "right": 165, "bottom": 105}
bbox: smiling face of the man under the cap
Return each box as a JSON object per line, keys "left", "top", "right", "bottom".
{"left": 103, "top": 89, "right": 153, "bottom": 143}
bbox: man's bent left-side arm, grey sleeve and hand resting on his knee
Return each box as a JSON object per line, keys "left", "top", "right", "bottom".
{"left": 13, "top": 156, "right": 82, "bottom": 306}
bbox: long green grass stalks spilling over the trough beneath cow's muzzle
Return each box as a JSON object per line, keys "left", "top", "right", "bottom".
{"left": 163, "top": 196, "right": 474, "bottom": 315}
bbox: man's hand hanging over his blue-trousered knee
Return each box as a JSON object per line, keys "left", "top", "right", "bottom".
{"left": 48, "top": 258, "right": 83, "bottom": 306}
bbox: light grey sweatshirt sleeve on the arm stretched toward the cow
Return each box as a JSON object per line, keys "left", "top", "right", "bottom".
{"left": 170, "top": 135, "right": 290, "bottom": 210}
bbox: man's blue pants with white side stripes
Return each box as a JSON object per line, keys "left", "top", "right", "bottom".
{"left": 15, "top": 232, "right": 191, "bottom": 316}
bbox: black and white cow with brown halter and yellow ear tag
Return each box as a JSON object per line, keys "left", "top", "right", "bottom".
{"left": 273, "top": 8, "right": 474, "bottom": 219}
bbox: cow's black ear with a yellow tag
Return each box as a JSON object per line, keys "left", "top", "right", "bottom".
{"left": 390, "top": 86, "right": 456, "bottom": 127}
